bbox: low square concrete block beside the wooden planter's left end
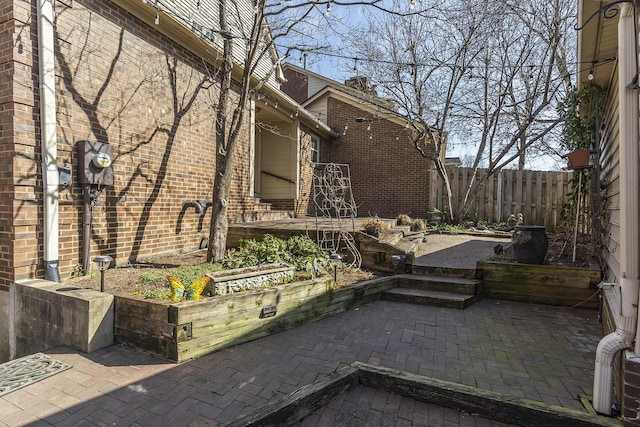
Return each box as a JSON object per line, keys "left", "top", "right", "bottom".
{"left": 11, "top": 279, "right": 114, "bottom": 357}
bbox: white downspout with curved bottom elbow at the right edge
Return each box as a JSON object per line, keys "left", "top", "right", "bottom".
{"left": 593, "top": 3, "right": 640, "bottom": 415}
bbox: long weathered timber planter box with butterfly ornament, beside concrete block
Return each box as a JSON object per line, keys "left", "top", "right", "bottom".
{"left": 114, "top": 277, "right": 395, "bottom": 362}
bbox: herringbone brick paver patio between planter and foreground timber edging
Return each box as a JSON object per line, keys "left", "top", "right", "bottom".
{"left": 0, "top": 300, "right": 601, "bottom": 426}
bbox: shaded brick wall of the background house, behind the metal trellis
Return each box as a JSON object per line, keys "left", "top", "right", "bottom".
{"left": 320, "top": 98, "right": 433, "bottom": 218}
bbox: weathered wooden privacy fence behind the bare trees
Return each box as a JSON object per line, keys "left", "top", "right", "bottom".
{"left": 429, "top": 166, "right": 573, "bottom": 230}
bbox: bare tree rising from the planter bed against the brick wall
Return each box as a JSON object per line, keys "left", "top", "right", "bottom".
{"left": 202, "top": 0, "right": 422, "bottom": 261}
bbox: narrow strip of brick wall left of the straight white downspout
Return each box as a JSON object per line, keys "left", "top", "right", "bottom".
{"left": 0, "top": 1, "right": 42, "bottom": 288}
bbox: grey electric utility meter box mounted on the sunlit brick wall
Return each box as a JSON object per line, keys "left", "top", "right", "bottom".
{"left": 77, "top": 141, "right": 113, "bottom": 185}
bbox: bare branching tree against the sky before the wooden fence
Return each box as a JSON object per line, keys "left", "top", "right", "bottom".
{"left": 344, "top": 0, "right": 575, "bottom": 221}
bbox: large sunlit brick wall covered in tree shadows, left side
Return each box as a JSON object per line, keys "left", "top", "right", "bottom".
{"left": 0, "top": 0, "right": 253, "bottom": 285}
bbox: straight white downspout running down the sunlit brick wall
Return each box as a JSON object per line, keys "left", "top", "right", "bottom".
{"left": 37, "top": 0, "right": 60, "bottom": 282}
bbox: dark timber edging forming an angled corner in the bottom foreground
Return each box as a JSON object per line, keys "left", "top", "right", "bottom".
{"left": 227, "top": 362, "right": 621, "bottom": 427}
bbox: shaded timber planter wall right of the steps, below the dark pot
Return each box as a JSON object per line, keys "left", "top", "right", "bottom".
{"left": 478, "top": 261, "right": 601, "bottom": 309}
